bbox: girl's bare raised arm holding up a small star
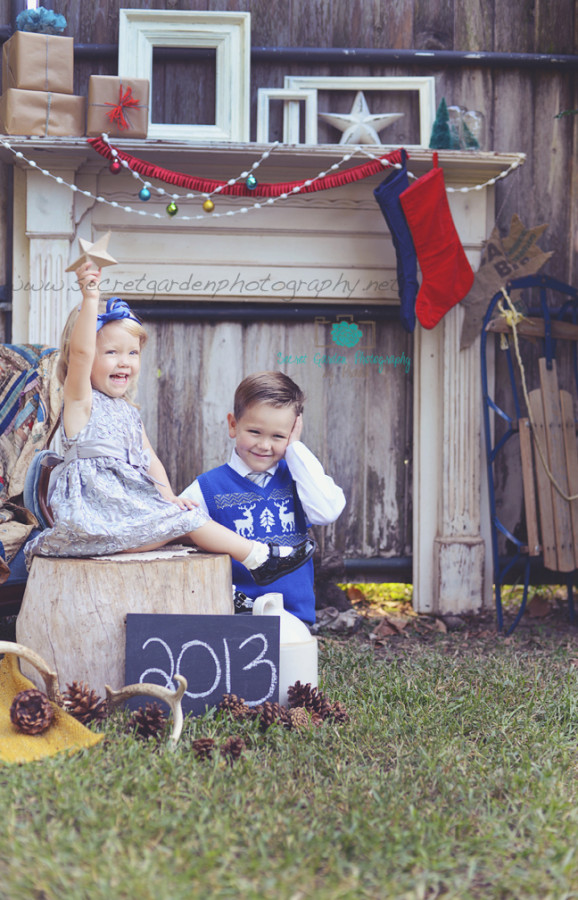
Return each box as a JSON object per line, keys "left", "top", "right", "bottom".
{"left": 63, "top": 260, "right": 100, "bottom": 437}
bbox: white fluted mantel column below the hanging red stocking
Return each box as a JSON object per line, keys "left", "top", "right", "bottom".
{"left": 414, "top": 284, "right": 491, "bottom": 613}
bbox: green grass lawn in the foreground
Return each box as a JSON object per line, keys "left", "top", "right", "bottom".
{"left": 0, "top": 636, "right": 578, "bottom": 900}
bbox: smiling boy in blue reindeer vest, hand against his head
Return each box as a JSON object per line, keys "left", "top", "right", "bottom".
{"left": 181, "top": 372, "right": 345, "bottom": 624}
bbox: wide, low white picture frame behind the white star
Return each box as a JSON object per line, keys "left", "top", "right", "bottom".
{"left": 283, "top": 75, "right": 436, "bottom": 149}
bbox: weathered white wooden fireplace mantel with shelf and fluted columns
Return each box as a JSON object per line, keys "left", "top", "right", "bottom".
{"left": 0, "top": 136, "right": 525, "bottom": 613}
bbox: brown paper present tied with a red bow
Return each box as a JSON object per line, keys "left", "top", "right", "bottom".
{"left": 86, "top": 75, "right": 149, "bottom": 138}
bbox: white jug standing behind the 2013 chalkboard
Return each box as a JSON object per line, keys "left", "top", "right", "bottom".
{"left": 253, "top": 594, "right": 317, "bottom": 706}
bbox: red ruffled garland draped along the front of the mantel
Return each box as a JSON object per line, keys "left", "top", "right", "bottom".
{"left": 88, "top": 138, "right": 402, "bottom": 197}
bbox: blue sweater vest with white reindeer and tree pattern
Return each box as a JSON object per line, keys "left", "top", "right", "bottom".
{"left": 198, "top": 459, "right": 315, "bottom": 624}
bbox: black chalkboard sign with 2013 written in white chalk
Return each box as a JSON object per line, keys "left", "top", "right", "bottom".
{"left": 125, "top": 613, "right": 279, "bottom": 715}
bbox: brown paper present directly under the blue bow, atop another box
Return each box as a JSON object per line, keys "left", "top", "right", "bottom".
{"left": 2, "top": 31, "right": 74, "bottom": 94}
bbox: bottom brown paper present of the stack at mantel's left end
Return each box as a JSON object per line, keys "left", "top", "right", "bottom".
{"left": 0, "top": 88, "right": 86, "bottom": 137}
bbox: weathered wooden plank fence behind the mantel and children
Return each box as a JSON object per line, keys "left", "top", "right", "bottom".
{"left": 0, "top": 0, "right": 578, "bottom": 572}
